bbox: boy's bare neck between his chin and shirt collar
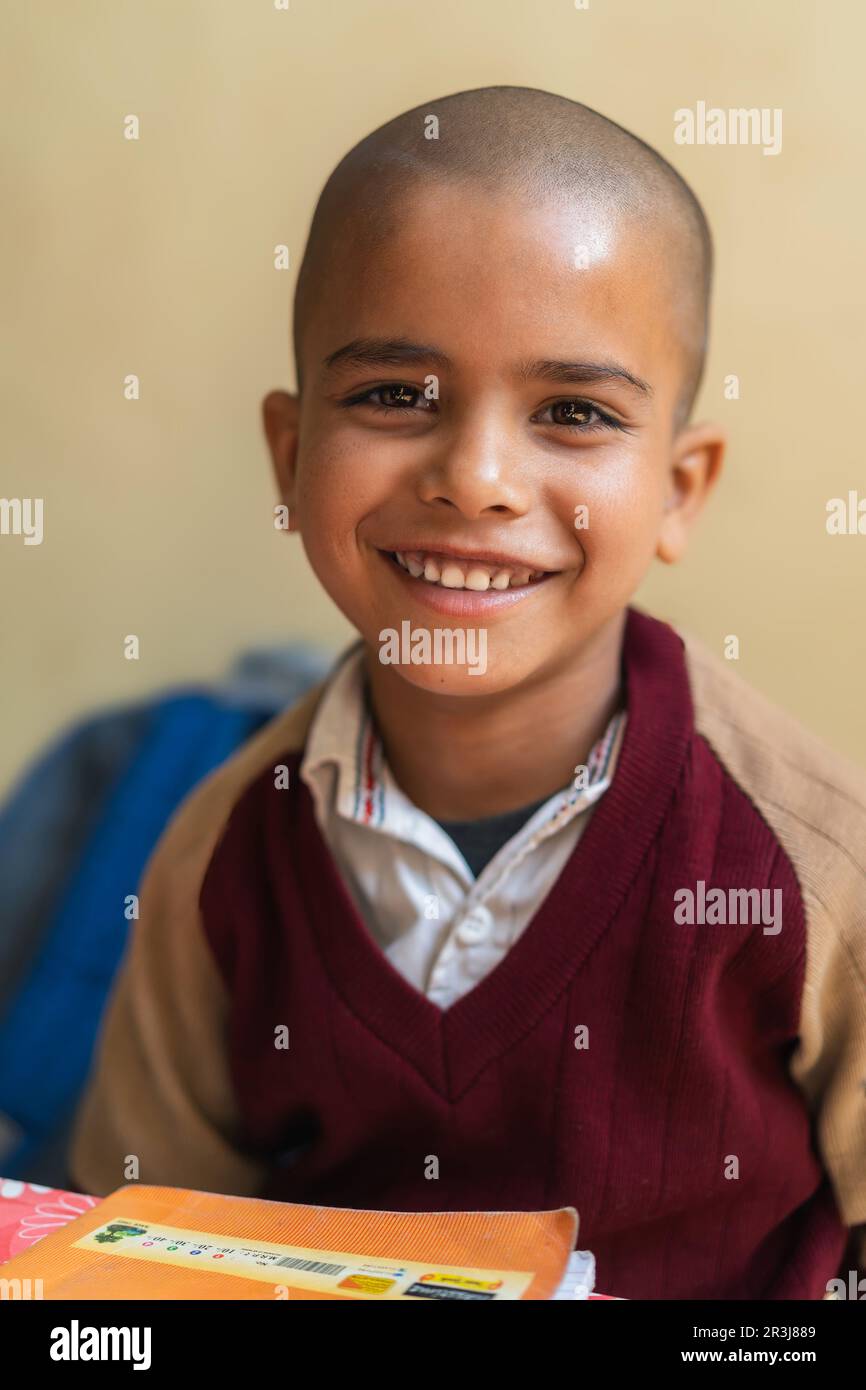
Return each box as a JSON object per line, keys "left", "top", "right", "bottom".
{"left": 366, "top": 612, "right": 626, "bottom": 820}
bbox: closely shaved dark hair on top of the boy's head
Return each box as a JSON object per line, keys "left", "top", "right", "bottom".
{"left": 293, "top": 86, "right": 713, "bottom": 423}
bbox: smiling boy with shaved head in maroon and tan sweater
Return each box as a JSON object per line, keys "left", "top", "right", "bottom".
{"left": 72, "top": 88, "right": 866, "bottom": 1298}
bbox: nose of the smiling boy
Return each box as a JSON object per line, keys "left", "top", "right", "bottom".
{"left": 418, "top": 431, "right": 530, "bottom": 518}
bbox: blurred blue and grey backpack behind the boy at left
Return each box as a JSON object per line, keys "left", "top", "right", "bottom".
{"left": 0, "top": 648, "right": 328, "bottom": 1186}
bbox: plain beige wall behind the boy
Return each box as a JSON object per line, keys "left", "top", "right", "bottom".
{"left": 0, "top": 0, "right": 866, "bottom": 783}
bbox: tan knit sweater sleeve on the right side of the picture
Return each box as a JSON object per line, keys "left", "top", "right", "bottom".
{"left": 680, "top": 631, "right": 866, "bottom": 1223}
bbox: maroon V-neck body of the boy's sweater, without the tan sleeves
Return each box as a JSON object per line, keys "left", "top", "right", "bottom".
{"left": 202, "top": 610, "right": 847, "bottom": 1298}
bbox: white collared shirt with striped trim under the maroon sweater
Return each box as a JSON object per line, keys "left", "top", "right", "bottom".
{"left": 300, "top": 646, "right": 626, "bottom": 1009}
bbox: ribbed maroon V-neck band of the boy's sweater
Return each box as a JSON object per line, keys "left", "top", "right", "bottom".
{"left": 289, "top": 609, "right": 694, "bottom": 1101}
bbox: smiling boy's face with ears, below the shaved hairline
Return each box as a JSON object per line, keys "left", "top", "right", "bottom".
{"left": 265, "top": 183, "right": 721, "bottom": 695}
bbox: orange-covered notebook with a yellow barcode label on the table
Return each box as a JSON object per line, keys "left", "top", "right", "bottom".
{"left": 3, "top": 1184, "right": 577, "bottom": 1302}
